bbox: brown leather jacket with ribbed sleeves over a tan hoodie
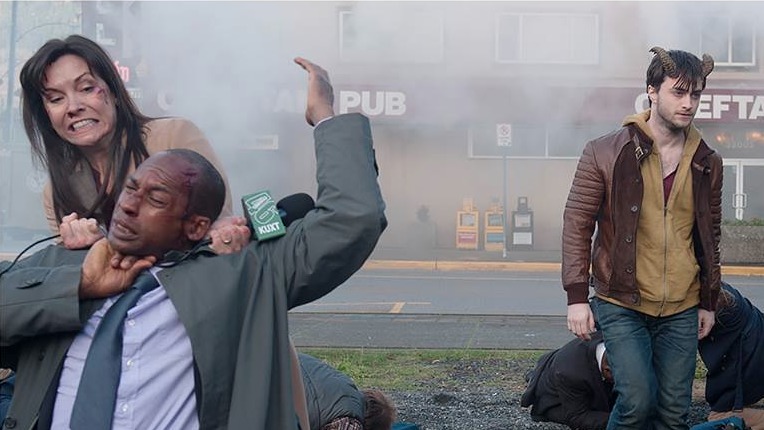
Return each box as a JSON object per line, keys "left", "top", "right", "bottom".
{"left": 562, "top": 125, "right": 722, "bottom": 311}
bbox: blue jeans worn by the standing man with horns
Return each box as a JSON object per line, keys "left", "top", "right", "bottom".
{"left": 592, "top": 297, "right": 698, "bottom": 430}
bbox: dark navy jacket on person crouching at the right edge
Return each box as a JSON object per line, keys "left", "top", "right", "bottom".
{"left": 698, "top": 282, "right": 764, "bottom": 412}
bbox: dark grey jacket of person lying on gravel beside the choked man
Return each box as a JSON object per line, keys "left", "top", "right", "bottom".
{"left": 299, "top": 353, "right": 365, "bottom": 430}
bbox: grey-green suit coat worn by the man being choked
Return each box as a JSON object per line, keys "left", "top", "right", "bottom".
{"left": 0, "top": 114, "right": 387, "bottom": 430}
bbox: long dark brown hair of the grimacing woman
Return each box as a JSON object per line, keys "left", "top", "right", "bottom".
{"left": 19, "top": 35, "right": 152, "bottom": 225}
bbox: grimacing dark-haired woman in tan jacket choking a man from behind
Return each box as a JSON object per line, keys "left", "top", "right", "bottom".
{"left": 20, "top": 35, "right": 249, "bottom": 252}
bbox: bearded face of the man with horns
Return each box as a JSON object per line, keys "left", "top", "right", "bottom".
{"left": 647, "top": 77, "right": 703, "bottom": 131}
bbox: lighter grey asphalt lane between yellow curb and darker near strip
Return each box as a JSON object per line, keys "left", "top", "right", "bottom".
{"left": 293, "top": 270, "right": 764, "bottom": 316}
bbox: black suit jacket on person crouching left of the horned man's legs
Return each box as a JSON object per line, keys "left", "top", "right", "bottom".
{"left": 521, "top": 332, "right": 615, "bottom": 429}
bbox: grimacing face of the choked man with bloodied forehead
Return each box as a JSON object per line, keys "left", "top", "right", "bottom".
{"left": 108, "top": 153, "right": 196, "bottom": 258}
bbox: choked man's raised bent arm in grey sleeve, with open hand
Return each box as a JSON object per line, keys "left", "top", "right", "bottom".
{"left": 280, "top": 58, "right": 387, "bottom": 307}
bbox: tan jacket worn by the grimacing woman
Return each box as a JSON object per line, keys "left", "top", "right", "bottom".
{"left": 42, "top": 118, "right": 233, "bottom": 234}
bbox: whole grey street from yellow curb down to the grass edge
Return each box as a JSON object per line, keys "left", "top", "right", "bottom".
{"left": 289, "top": 270, "right": 764, "bottom": 349}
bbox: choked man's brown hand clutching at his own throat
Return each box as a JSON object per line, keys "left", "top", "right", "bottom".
{"left": 80, "top": 239, "right": 156, "bottom": 299}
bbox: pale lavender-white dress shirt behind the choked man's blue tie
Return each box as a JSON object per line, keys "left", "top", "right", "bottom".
{"left": 52, "top": 269, "right": 199, "bottom": 430}
